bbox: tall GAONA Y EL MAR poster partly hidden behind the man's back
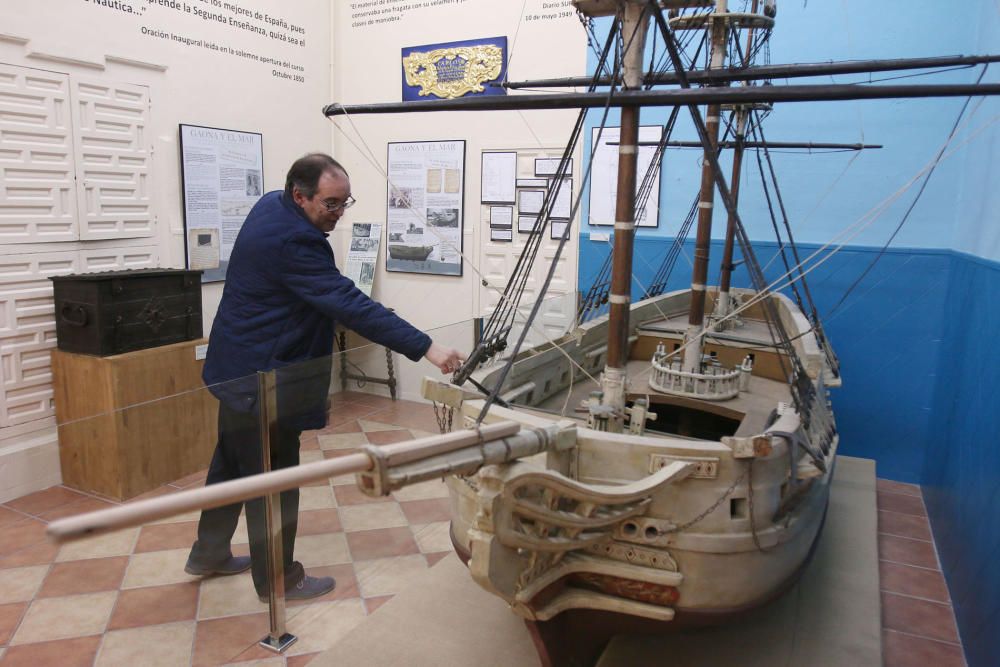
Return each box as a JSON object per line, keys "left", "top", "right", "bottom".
{"left": 180, "top": 124, "right": 264, "bottom": 283}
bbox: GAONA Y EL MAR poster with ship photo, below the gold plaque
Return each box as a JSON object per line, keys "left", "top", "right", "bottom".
{"left": 385, "top": 139, "right": 465, "bottom": 276}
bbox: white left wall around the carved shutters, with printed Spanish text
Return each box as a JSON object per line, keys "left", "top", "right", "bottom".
{"left": 0, "top": 0, "right": 332, "bottom": 500}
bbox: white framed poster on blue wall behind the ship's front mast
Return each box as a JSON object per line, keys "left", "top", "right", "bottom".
{"left": 590, "top": 125, "right": 663, "bottom": 227}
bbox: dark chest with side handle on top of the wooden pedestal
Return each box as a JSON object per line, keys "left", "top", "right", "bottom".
{"left": 51, "top": 269, "right": 202, "bottom": 357}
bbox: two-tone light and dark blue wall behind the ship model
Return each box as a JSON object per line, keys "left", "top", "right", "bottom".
{"left": 579, "top": 0, "right": 1000, "bottom": 667}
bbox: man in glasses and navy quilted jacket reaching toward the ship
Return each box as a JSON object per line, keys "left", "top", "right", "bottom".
{"left": 184, "top": 153, "right": 462, "bottom": 599}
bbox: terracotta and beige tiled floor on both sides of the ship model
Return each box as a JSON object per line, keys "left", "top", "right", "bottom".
{"left": 0, "top": 393, "right": 964, "bottom": 667}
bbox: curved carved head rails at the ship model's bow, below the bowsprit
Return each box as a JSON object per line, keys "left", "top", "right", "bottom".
{"left": 469, "top": 461, "right": 694, "bottom": 620}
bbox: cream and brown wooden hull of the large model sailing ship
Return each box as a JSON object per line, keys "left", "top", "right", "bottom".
{"left": 426, "top": 291, "right": 838, "bottom": 665}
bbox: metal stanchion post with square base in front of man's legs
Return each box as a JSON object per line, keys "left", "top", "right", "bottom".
{"left": 257, "top": 370, "right": 298, "bottom": 653}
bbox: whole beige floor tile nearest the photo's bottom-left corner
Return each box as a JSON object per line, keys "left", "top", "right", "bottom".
{"left": 10, "top": 591, "right": 118, "bottom": 645}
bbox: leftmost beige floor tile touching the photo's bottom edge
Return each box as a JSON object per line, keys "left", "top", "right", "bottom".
{"left": 94, "top": 621, "right": 195, "bottom": 667}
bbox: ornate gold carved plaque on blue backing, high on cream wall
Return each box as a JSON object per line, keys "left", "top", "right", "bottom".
{"left": 403, "top": 44, "right": 503, "bottom": 100}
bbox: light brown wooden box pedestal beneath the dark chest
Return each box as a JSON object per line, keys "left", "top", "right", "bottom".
{"left": 52, "top": 339, "right": 218, "bottom": 500}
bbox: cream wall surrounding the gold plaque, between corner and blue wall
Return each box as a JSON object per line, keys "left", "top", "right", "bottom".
{"left": 330, "top": 0, "right": 587, "bottom": 399}
